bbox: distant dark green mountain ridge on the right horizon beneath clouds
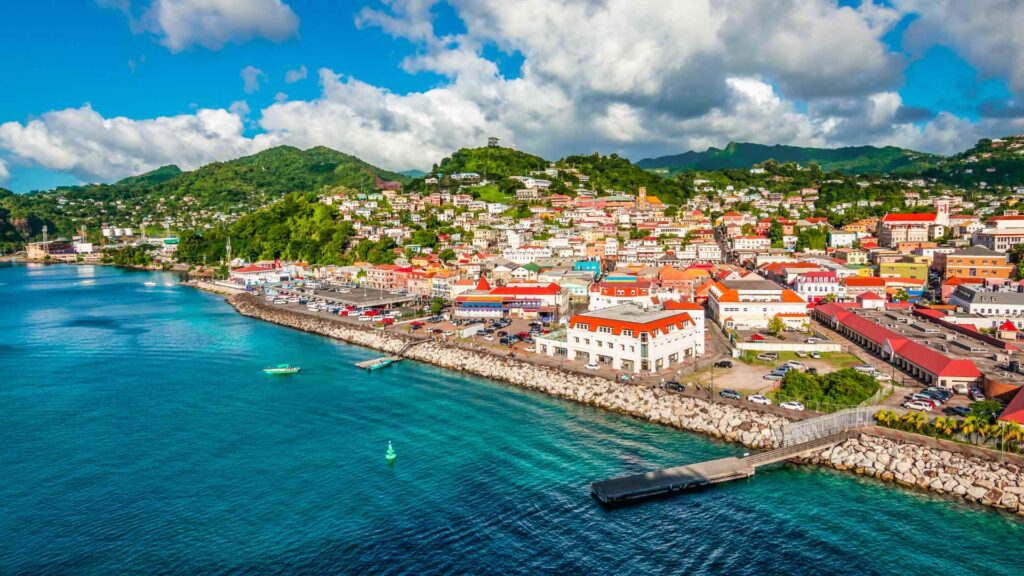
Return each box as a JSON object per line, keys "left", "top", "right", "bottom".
{"left": 637, "top": 142, "right": 941, "bottom": 174}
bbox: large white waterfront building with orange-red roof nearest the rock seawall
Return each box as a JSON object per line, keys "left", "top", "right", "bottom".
{"left": 537, "top": 303, "right": 705, "bottom": 374}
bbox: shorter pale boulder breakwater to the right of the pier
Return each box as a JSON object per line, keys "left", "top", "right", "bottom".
{"left": 802, "top": 434, "right": 1024, "bottom": 515}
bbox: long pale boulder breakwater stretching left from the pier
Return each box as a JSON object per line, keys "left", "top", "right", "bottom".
{"left": 227, "top": 294, "right": 787, "bottom": 448}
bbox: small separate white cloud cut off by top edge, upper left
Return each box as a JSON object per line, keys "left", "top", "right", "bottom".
{"left": 103, "top": 0, "right": 299, "bottom": 52}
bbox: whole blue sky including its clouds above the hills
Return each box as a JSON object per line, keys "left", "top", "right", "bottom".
{"left": 0, "top": 0, "right": 1024, "bottom": 192}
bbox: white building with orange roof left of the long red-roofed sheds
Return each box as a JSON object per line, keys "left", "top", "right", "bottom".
{"left": 708, "top": 277, "right": 807, "bottom": 330}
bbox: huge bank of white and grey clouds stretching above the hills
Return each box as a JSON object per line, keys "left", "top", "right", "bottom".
{"left": 0, "top": 0, "right": 1024, "bottom": 178}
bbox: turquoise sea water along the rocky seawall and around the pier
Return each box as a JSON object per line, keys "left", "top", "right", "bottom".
{"left": 0, "top": 264, "right": 1024, "bottom": 575}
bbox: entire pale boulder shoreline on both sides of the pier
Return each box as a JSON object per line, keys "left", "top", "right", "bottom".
{"left": 227, "top": 294, "right": 1024, "bottom": 515}
